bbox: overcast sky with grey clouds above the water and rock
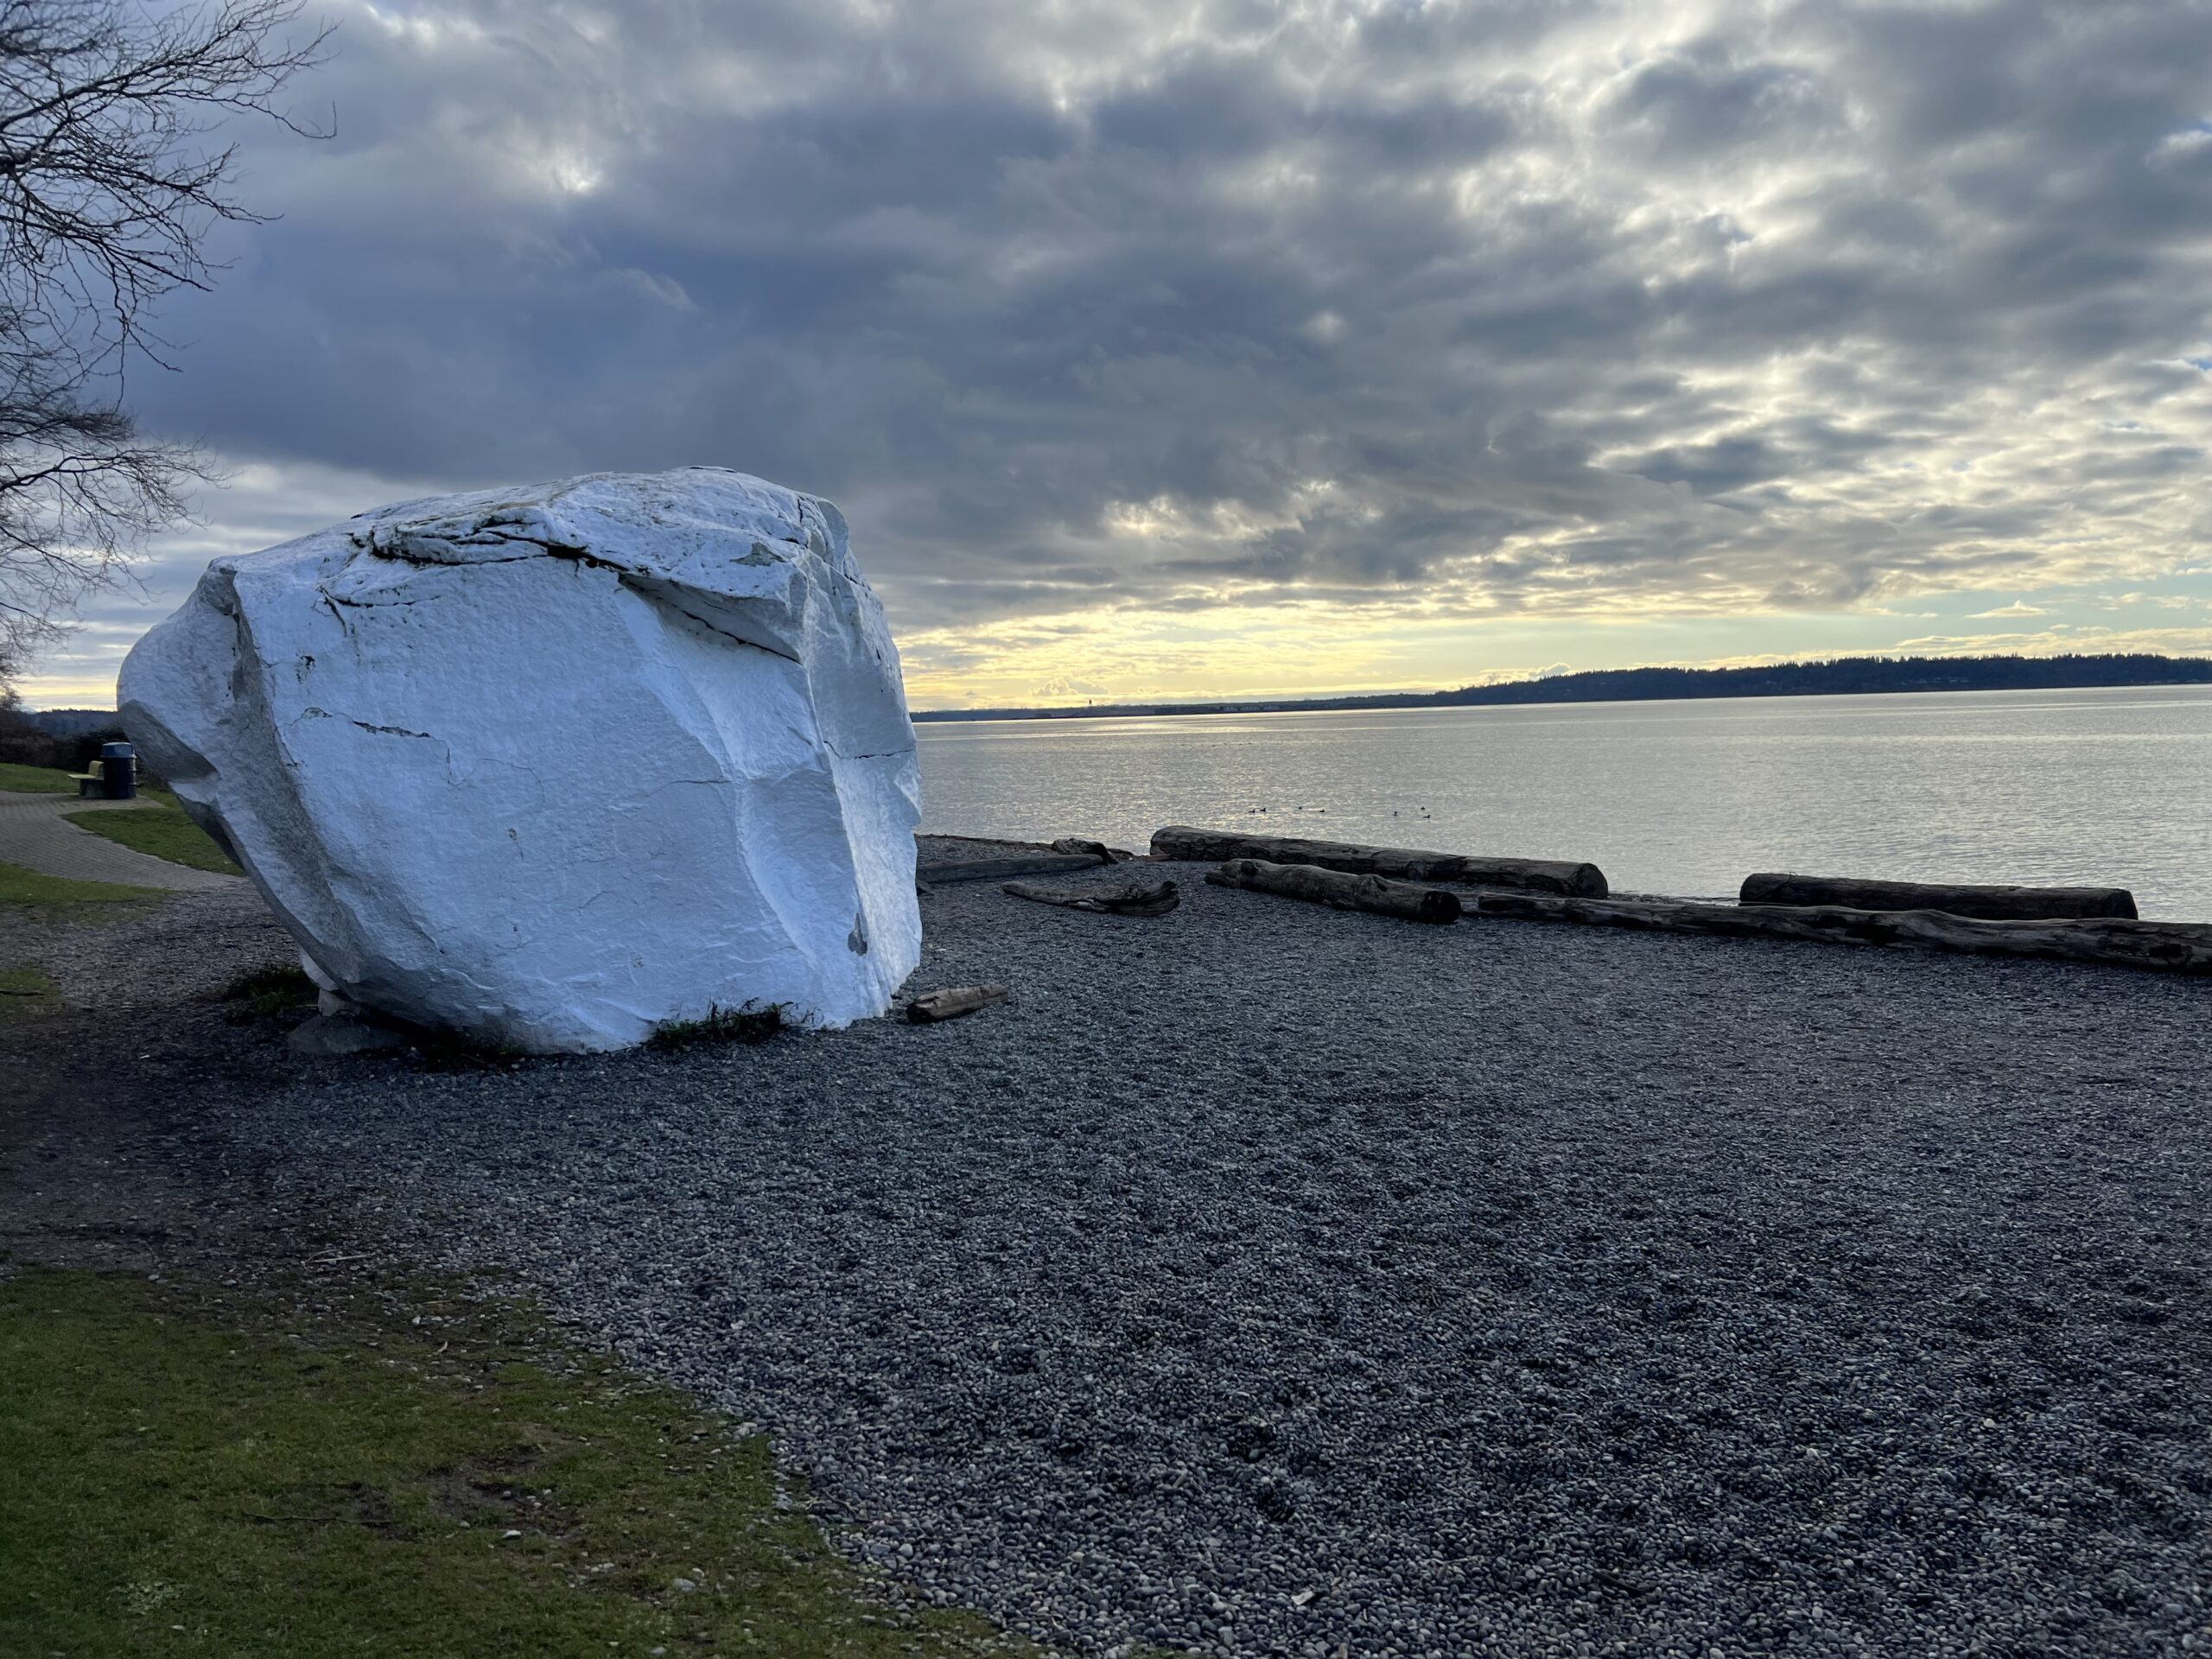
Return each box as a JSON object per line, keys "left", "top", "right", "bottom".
{"left": 27, "top": 0, "right": 2212, "bottom": 708}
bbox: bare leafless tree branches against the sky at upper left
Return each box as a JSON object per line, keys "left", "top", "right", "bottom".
{"left": 0, "top": 0, "right": 329, "bottom": 686}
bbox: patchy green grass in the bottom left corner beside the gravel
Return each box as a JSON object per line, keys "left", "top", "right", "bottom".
{"left": 0, "top": 1272, "right": 1057, "bottom": 1659}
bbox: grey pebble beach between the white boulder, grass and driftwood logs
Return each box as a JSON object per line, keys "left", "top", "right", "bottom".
{"left": 125, "top": 868, "right": 2212, "bottom": 1655}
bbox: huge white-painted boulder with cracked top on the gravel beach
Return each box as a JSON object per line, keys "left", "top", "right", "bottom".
{"left": 119, "top": 467, "right": 923, "bottom": 1051}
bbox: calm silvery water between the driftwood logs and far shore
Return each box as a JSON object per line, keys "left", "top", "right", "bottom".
{"left": 916, "top": 686, "right": 2212, "bottom": 920}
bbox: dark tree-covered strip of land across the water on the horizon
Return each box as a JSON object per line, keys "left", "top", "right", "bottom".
{"left": 913, "top": 652, "right": 2212, "bottom": 723}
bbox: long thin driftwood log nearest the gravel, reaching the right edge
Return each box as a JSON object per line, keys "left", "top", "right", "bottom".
{"left": 1473, "top": 893, "right": 2212, "bottom": 973}
